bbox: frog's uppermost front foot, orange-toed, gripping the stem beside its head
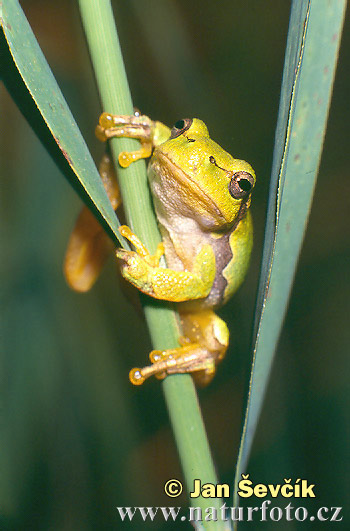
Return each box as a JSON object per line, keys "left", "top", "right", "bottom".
{"left": 95, "top": 112, "right": 154, "bottom": 168}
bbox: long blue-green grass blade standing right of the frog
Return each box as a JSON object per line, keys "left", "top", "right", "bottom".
{"left": 234, "top": 0, "right": 346, "bottom": 504}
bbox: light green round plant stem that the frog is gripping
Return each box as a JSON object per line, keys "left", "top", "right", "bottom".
{"left": 79, "top": 0, "right": 230, "bottom": 530}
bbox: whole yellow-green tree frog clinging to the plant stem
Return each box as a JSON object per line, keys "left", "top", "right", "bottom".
{"left": 65, "top": 113, "right": 255, "bottom": 385}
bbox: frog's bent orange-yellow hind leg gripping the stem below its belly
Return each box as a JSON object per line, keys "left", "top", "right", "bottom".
{"left": 130, "top": 310, "right": 229, "bottom": 385}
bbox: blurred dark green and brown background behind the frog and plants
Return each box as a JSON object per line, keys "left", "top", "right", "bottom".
{"left": 0, "top": 0, "right": 350, "bottom": 530}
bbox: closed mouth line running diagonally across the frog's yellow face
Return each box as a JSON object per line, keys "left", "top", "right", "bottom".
{"left": 153, "top": 151, "right": 237, "bottom": 224}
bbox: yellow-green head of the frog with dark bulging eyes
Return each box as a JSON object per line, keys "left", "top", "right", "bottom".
{"left": 151, "top": 118, "right": 256, "bottom": 230}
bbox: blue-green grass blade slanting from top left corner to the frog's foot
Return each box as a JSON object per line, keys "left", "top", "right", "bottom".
{"left": 0, "top": 0, "right": 127, "bottom": 246}
